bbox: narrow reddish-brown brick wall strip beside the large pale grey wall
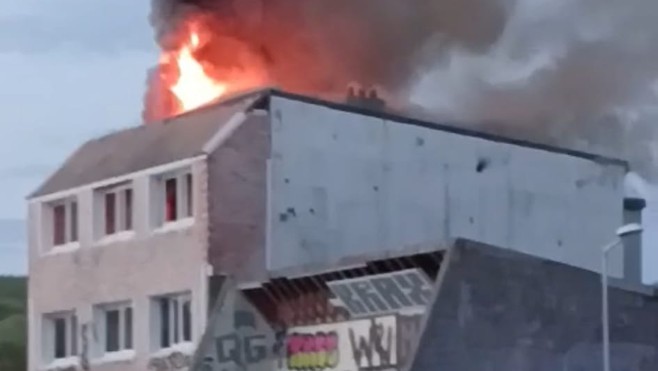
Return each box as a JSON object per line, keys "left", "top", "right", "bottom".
{"left": 208, "top": 113, "right": 270, "bottom": 280}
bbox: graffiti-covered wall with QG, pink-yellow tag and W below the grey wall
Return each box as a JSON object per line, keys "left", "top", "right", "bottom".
{"left": 193, "top": 269, "right": 434, "bottom": 371}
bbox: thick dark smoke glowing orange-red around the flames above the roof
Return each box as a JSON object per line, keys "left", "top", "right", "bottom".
{"left": 147, "top": 0, "right": 505, "bottom": 117}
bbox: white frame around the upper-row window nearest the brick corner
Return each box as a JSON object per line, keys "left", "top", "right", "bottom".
{"left": 153, "top": 167, "right": 196, "bottom": 229}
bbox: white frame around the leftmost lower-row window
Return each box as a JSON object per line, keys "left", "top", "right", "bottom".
{"left": 42, "top": 311, "right": 79, "bottom": 364}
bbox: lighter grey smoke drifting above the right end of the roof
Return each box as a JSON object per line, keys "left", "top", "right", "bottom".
{"left": 411, "top": 0, "right": 658, "bottom": 176}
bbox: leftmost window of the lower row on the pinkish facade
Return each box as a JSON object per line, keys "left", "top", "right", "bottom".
{"left": 43, "top": 312, "right": 78, "bottom": 362}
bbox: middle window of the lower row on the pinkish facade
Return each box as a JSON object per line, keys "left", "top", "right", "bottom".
{"left": 95, "top": 303, "right": 133, "bottom": 354}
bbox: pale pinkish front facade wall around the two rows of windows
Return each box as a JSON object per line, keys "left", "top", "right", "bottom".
{"left": 29, "top": 161, "right": 208, "bottom": 371}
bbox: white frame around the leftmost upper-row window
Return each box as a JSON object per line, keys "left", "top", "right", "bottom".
{"left": 42, "top": 196, "right": 80, "bottom": 252}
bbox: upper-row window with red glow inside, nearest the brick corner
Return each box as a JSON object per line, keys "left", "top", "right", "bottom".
{"left": 158, "top": 171, "right": 194, "bottom": 225}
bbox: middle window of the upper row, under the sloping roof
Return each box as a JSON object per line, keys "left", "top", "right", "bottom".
{"left": 97, "top": 184, "right": 133, "bottom": 237}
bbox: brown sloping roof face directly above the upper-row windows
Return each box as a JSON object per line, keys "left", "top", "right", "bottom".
{"left": 29, "top": 91, "right": 263, "bottom": 198}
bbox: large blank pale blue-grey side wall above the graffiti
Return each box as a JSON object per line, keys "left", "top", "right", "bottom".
{"left": 268, "top": 96, "right": 626, "bottom": 275}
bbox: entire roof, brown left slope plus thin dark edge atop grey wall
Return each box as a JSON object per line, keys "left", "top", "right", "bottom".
{"left": 29, "top": 87, "right": 629, "bottom": 198}
